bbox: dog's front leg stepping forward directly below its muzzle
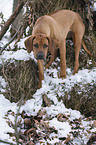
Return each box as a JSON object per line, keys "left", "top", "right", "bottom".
{"left": 37, "top": 60, "right": 44, "bottom": 89}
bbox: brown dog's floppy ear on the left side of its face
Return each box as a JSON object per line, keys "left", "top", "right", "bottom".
{"left": 24, "top": 36, "right": 36, "bottom": 53}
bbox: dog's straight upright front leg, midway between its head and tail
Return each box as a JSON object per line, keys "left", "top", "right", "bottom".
{"left": 59, "top": 39, "right": 66, "bottom": 78}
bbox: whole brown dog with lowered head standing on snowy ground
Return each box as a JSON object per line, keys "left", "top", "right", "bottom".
{"left": 25, "top": 10, "right": 92, "bottom": 88}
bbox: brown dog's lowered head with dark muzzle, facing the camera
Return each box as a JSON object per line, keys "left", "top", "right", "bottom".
{"left": 24, "top": 35, "right": 50, "bottom": 60}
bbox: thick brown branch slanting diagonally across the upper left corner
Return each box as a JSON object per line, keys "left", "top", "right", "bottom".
{"left": 0, "top": 0, "right": 24, "bottom": 40}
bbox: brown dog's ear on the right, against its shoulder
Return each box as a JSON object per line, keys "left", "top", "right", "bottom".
{"left": 46, "top": 36, "right": 57, "bottom": 54}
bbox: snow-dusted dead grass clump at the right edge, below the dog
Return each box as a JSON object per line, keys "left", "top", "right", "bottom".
{"left": 63, "top": 80, "right": 96, "bottom": 119}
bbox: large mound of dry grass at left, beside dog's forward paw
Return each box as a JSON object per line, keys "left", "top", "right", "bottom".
{"left": 3, "top": 60, "right": 38, "bottom": 102}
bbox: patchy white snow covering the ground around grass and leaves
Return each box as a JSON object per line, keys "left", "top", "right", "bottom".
{"left": 0, "top": 0, "right": 96, "bottom": 145}
